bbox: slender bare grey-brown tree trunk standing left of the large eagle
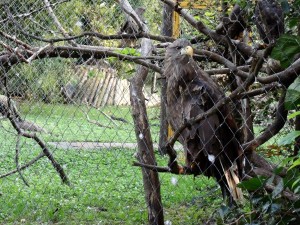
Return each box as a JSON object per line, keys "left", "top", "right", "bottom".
{"left": 118, "top": 0, "right": 164, "bottom": 225}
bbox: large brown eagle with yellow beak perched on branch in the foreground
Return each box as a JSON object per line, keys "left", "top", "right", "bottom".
{"left": 164, "top": 39, "right": 244, "bottom": 201}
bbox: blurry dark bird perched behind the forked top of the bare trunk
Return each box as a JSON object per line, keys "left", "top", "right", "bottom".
{"left": 119, "top": 7, "right": 145, "bottom": 47}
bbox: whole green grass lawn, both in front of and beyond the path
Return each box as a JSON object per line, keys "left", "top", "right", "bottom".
{"left": 0, "top": 103, "right": 222, "bottom": 225}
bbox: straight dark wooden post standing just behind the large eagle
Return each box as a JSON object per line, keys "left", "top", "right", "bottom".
{"left": 158, "top": 4, "right": 173, "bottom": 155}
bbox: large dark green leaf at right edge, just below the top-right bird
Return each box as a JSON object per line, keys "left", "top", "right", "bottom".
{"left": 271, "top": 34, "right": 300, "bottom": 68}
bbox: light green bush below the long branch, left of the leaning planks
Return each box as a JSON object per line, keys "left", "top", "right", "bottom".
{"left": 9, "top": 58, "right": 74, "bottom": 103}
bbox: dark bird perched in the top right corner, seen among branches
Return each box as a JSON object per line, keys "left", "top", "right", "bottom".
{"left": 254, "top": 0, "right": 284, "bottom": 44}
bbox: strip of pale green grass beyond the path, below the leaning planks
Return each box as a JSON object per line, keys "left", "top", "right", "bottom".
{"left": 16, "top": 103, "right": 159, "bottom": 142}
